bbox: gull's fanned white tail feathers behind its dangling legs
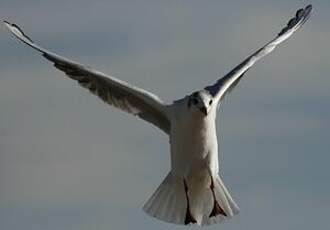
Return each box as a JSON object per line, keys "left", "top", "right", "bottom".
{"left": 143, "top": 173, "right": 239, "bottom": 225}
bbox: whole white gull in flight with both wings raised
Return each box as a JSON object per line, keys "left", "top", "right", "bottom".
{"left": 4, "top": 5, "right": 312, "bottom": 225}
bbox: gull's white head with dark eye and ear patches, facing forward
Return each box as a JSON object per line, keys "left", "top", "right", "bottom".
{"left": 187, "top": 90, "right": 213, "bottom": 116}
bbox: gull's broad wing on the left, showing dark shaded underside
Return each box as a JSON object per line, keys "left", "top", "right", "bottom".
{"left": 4, "top": 21, "right": 171, "bottom": 134}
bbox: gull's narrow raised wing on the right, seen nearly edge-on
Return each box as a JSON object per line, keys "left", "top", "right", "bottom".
{"left": 205, "top": 5, "right": 312, "bottom": 102}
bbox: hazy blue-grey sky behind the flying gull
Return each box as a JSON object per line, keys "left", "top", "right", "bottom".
{"left": 0, "top": 0, "right": 330, "bottom": 230}
